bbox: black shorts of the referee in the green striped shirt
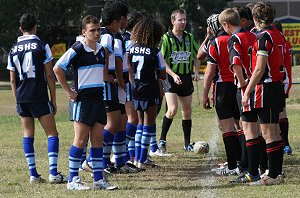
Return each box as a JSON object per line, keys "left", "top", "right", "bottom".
{"left": 162, "top": 74, "right": 194, "bottom": 97}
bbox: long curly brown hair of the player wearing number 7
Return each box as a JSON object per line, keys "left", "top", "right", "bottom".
{"left": 131, "top": 18, "right": 164, "bottom": 48}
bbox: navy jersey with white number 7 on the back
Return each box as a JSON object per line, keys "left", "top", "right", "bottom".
{"left": 128, "top": 43, "right": 166, "bottom": 100}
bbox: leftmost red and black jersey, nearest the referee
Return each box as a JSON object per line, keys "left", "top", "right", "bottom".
{"left": 207, "top": 32, "right": 234, "bottom": 82}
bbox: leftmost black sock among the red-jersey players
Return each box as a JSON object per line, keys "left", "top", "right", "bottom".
{"left": 223, "top": 132, "right": 238, "bottom": 170}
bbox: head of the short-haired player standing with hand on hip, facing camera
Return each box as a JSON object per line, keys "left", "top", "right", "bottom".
{"left": 81, "top": 15, "right": 100, "bottom": 42}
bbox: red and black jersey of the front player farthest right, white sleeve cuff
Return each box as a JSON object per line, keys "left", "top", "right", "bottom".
{"left": 252, "top": 26, "right": 285, "bottom": 83}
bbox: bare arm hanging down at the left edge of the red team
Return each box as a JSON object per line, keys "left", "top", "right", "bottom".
{"left": 202, "top": 63, "right": 217, "bottom": 109}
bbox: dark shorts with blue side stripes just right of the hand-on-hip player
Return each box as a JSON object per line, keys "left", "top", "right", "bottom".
{"left": 103, "top": 82, "right": 120, "bottom": 113}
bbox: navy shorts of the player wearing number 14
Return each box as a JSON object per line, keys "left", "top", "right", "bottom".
{"left": 17, "top": 102, "right": 54, "bottom": 118}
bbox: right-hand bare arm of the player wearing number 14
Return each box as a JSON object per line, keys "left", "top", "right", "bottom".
{"left": 45, "top": 61, "right": 57, "bottom": 114}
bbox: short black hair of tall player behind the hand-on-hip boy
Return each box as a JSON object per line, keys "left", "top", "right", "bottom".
{"left": 101, "top": 3, "right": 122, "bottom": 26}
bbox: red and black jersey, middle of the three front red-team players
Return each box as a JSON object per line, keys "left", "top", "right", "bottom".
{"left": 228, "top": 28, "right": 256, "bottom": 78}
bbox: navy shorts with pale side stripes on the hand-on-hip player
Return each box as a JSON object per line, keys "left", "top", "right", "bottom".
{"left": 69, "top": 100, "right": 106, "bottom": 126}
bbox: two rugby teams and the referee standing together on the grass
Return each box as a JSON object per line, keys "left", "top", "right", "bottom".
{"left": 7, "top": 0, "right": 292, "bottom": 190}
